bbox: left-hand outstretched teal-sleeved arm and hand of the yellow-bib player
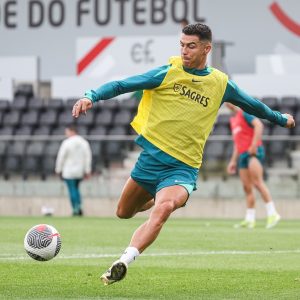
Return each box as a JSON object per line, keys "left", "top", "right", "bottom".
{"left": 72, "top": 65, "right": 170, "bottom": 118}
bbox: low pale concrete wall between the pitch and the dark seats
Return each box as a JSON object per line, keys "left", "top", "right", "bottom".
{"left": 0, "top": 177, "right": 300, "bottom": 219}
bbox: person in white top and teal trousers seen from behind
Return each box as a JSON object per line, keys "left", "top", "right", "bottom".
{"left": 55, "top": 125, "right": 92, "bottom": 216}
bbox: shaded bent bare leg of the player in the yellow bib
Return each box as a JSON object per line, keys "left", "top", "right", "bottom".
{"left": 117, "top": 177, "right": 153, "bottom": 219}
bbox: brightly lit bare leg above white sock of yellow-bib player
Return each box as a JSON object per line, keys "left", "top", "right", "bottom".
{"left": 130, "top": 185, "right": 188, "bottom": 253}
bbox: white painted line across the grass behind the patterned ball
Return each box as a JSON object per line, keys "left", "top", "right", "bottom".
{"left": 0, "top": 249, "right": 300, "bottom": 261}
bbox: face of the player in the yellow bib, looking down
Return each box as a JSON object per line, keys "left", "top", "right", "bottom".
{"left": 180, "top": 33, "right": 211, "bottom": 69}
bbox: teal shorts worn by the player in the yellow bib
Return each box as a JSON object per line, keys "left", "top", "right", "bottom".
{"left": 131, "top": 151, "right": 199, "bottom": 198}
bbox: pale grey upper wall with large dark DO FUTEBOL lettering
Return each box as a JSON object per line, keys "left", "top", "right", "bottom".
{"left": 0, "top": 0, "right": 300, "bottom": 80}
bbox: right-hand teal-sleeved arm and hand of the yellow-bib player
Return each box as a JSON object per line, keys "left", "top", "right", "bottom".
{"left": 223, "top": 80, "right": 295, "bottom": 128}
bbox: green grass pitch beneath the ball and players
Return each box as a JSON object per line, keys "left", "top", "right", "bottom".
{"left": 0, "top": 217, "right": 300, "bottom": 300}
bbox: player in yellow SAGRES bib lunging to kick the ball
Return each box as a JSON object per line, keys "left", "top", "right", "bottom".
{"left": 72, "top": 23, "right": 295, "bottom": 284}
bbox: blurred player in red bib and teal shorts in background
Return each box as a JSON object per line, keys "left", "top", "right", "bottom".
{"left": 226, "top": 103, "right": 280, "bottom": 229}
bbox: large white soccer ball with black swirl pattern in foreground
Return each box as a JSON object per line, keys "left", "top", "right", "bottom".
{"left": 24, "top": 224, "right": 61, "bottom": 261}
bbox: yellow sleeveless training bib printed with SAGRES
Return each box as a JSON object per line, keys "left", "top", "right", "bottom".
{"left": 131, "top": 57, "right": 228, "bottom": 168}
